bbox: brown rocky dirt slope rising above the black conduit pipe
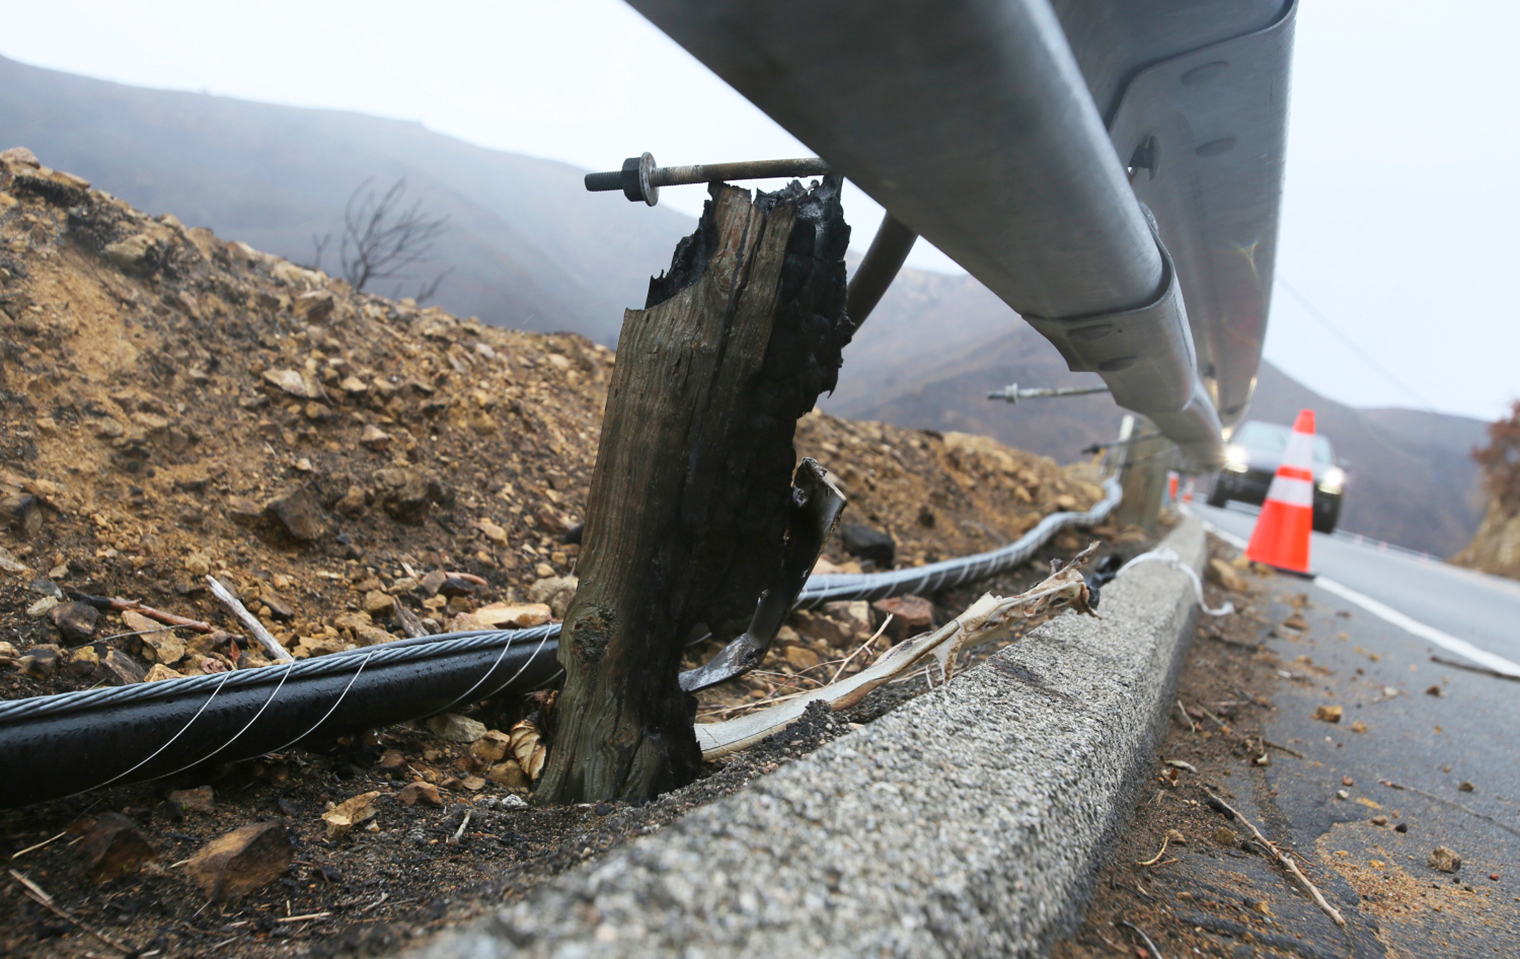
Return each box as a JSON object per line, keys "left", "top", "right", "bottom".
{"left": 0, "top": 142, "right": 1099, "bottom": 705}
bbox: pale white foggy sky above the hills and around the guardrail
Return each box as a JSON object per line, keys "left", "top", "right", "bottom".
{"left": 0, "top": 0, "right": 1520, "bottom": 419}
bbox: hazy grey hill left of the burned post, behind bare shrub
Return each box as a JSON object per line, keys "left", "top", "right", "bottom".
{"left": 0, "top": 58, "right": 692, "bottom": 345}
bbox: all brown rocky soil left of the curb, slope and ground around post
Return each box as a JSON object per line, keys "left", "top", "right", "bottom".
{"left": 0, "top": 150, "right": 1137, "bottom": 956}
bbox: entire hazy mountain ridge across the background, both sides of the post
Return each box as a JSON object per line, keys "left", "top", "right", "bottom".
{"left": 0, "top": 56, "right": 1484, "bottom": 556}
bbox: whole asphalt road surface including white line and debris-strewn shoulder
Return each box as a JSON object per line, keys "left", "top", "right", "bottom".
{"left": 1195, "top": 506, "right": 1520, "bottom": 959}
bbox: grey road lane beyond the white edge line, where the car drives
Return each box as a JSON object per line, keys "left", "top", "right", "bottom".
{"left": 1192, "top": 503, "right": 1520, "bottom": 672}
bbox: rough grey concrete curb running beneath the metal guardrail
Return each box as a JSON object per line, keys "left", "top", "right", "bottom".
{"left": 420, "top": 520, "right": 1205, "bottom": 959}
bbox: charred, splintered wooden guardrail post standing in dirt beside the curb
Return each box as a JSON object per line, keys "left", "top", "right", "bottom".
{"left": 538, "top": 176, "right": 853, "bottom": 802}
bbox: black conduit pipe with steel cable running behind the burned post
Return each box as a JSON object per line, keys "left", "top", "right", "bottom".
{"left": 0, "top": 479, "right": 1120, "bottom": 809}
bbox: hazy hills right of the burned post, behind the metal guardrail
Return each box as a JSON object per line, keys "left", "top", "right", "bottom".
{"left": 824, "top": 271, "right": 1485, "bottom": 556}
